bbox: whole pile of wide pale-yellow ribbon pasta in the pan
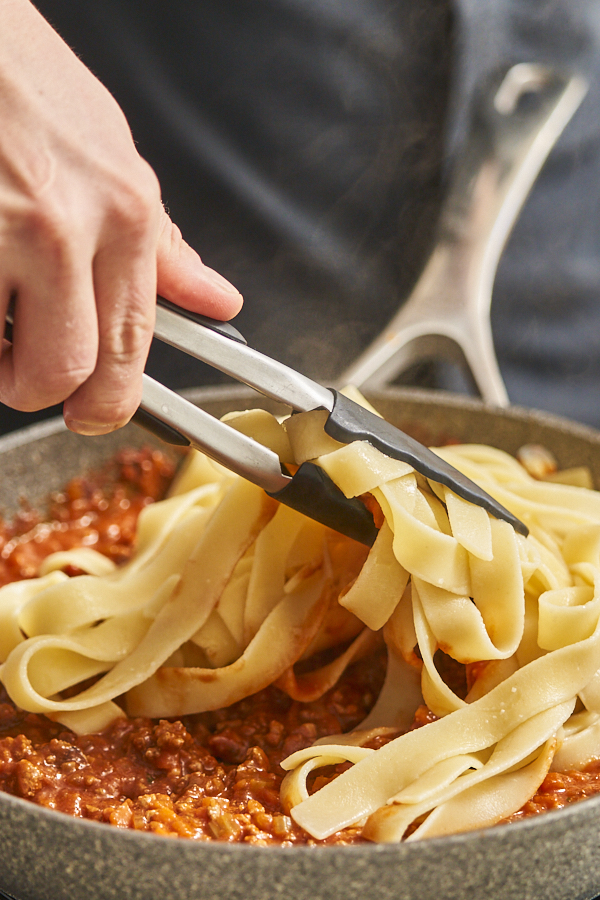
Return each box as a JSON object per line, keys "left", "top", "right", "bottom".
{"left": 0, "top": 398, "right": 600, "bottom": 842}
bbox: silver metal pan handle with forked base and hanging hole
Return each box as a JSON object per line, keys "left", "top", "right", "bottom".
{"left": 340, "top": 63, "right": 588, "bottom": 406}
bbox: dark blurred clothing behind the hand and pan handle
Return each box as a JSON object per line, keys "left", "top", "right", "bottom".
{"left": 0, "top": 0, "right": 600, "bottom": 431}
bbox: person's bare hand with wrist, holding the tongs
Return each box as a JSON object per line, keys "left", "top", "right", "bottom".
{"left": 0, "top": 0, "right": 242, "bottom": 434}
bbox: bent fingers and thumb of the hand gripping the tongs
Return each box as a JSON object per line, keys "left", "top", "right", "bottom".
{"left": 0, "top": 175, "right": 242, "bottom": 434}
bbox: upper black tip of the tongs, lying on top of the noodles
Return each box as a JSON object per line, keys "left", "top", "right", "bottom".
{"left": 325, "top": 391, "right": 529, "bottom": 537}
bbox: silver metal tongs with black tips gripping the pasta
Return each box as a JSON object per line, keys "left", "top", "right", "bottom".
{"left": 135, "top": 297, "right": 527, "bottom": 546}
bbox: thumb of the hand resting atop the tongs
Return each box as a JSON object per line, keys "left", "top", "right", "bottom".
{"left": 156, "top": 209, "right": 243, "bottom": 321}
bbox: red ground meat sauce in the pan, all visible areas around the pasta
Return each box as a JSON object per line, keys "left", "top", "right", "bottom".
{"left": 0, "top": 450, "right": 600, "bottom": 846}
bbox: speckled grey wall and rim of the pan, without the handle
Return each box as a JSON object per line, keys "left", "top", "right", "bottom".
{"left": 0, "top": 388, "right": 600, "bottom": 900}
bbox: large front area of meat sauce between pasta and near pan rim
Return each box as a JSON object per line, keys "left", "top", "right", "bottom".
{"left": 0, "top": 656, "right": 385, "bottom": 845}
